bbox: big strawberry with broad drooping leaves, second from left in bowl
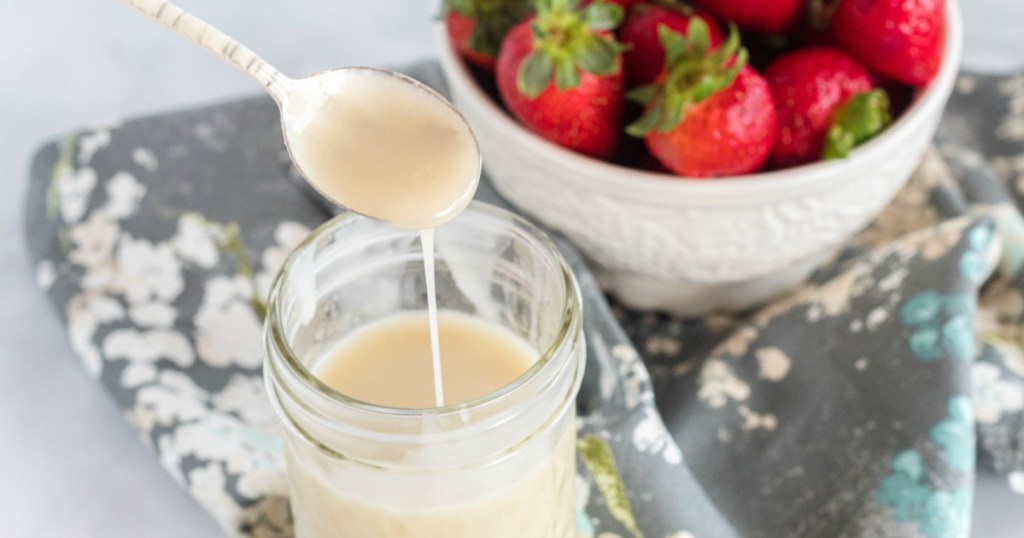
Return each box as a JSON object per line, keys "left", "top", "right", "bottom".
{"left": 496, "top": 0, "right": 624, "bottom": 158}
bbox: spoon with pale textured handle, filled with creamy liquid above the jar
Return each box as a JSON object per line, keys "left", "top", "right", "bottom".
{"left": 124, "top": 0, "right": 480, "bottom": 230}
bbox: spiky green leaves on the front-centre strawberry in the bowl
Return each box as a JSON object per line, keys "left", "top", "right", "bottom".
{"left": 626, "top": 16, "right": 748, "bottom": 137}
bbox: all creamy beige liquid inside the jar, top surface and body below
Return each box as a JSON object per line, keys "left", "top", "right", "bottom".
{"left": 286, "top": 311, "right": 575, "bottom": 538}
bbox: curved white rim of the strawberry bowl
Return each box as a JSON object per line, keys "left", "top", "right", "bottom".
{"left": 435, "top": 0, "right": 964, "bottom": 203}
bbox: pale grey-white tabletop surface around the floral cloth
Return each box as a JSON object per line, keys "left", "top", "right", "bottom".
{"left": 0, "top": 0, "right": 1024, "bottom": 538}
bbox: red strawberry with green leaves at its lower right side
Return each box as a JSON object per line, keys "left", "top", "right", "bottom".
{"left": 765, "top": 47, "right": 889, "bottom": 167}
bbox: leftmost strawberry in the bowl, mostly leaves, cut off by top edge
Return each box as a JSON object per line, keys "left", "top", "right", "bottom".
{"left": 441, "top": 0, "right": 534, "bottom": 71}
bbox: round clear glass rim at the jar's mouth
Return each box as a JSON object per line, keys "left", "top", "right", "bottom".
{"left": 265, "top": 201, "right": 582, "bottom": 418}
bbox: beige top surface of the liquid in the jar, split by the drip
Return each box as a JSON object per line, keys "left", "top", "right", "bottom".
{"left": 313, "top": 311, "right": 538, "bottom": 409}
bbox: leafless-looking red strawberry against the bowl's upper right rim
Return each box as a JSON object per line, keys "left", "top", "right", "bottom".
{"left": 831, "top": 0, "right": 946, "bottom": 87}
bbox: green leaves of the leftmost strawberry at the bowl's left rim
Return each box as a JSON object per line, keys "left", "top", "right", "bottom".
{"left": 441, "top": 0, "right": 534, "bottom": 57}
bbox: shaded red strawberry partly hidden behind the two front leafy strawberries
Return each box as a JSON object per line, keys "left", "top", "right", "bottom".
{"left": 618, "top": 4, "right": 722, "bottom": 88}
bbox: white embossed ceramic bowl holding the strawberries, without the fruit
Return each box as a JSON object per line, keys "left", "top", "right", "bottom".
{"left": 436, "top": 0, "right": 963, "bottom": 316}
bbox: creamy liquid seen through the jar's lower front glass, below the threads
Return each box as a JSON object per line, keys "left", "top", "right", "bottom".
{"left": 285, "top": 416, "right": 575, "bottom": 538}
